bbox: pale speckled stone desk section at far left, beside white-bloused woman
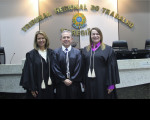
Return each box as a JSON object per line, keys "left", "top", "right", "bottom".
{"left": 0, "top": 60, "right": 26, "bottom": 93}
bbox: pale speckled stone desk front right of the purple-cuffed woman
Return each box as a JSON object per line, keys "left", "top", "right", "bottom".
{"left": 116, "top": 58, "right": 150, "bottom": 88}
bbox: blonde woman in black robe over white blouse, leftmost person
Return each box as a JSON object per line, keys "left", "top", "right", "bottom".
{"left": 20, "top": 30, "right": 54, "bottom": 99}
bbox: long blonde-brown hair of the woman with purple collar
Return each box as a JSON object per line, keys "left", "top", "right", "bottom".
{"left": 86, "top": 27, "right": 106, "bottom": 51}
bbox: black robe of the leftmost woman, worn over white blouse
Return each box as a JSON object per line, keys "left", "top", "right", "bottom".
{"left": 20, "top": 49, "right": 54, "bottom": 99}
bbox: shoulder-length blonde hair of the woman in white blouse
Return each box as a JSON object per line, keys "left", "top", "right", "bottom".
{"left": 33, "top": 30, "right": 50, "bottom": 50}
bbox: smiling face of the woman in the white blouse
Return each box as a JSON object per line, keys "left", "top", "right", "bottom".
{"left": 37, "top": 34, "right": 46, "bottom": 49}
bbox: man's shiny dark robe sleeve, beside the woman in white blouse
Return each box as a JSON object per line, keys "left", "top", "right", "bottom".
{"left": 52, "top": 52, "right": 66, "bottom": 83}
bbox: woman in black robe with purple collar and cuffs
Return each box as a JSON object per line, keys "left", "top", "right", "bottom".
{"left": 82, "top": 28, "right": 120, "bottom": 99}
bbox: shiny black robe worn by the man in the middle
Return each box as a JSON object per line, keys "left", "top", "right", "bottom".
{"left": 52, "top": 47, "right": 82, "bottom": 99}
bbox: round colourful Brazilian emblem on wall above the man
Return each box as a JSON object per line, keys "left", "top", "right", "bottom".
{"left": 72, "top": 13, "right": 87, "bottom": 29}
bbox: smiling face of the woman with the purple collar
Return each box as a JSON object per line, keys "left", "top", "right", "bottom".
{"left": 91, "top": 30, "right": 101, "bottom": 44}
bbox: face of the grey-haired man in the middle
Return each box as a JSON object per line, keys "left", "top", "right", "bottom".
{"left": 60, "top": 32, "right": 73, "bottom": 48}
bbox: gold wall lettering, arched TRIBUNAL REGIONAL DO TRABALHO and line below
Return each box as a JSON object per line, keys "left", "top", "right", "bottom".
{"left": 22, "top": 4, "right": 134, "bottom": 35}
